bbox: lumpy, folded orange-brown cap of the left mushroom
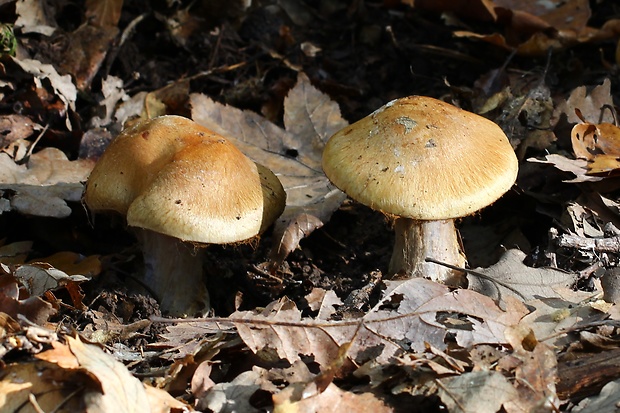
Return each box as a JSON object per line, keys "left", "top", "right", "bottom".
{"left": 84, "top": 116, "right": 286, "bottom": 243}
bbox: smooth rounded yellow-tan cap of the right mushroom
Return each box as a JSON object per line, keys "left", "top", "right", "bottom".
{"left": 323, "top": 96, "right": 518, "bottom": 220}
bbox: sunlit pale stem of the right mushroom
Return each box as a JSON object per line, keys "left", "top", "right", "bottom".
{"left": 389, "top": 217, "right": 465, "bottom": 287}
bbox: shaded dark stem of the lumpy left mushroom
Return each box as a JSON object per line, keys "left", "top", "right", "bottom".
{"left": 136, "top": 228, "right": 211, "bottom": 317}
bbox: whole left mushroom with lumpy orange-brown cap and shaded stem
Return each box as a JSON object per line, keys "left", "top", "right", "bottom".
{"left": 84, "top": 116, "right": 286, "bottom": 316}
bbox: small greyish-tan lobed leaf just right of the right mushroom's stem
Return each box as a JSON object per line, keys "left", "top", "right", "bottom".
{"left": 467, "top": 249, "right": 579, "bottom": 307}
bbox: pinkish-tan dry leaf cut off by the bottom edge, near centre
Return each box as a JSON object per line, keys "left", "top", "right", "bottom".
{"left": 273, "top": 383, "right": 394, "bottom": 413}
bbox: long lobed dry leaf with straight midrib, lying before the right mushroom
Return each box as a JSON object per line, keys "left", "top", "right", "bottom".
{"left": 229, "top": 278, "right": 528, "bottom": 367}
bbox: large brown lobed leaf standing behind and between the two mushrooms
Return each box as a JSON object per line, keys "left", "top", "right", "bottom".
{"left": 190, "top": 73, "right": 347, "bottom": 265}
